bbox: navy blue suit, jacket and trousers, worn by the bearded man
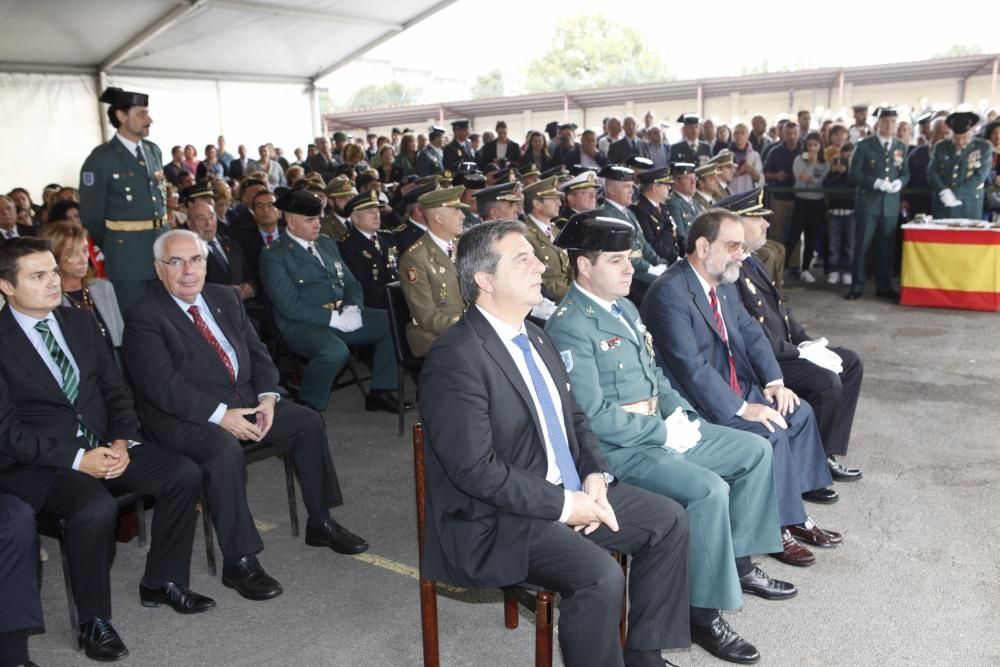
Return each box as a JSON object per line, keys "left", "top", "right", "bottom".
{"left": 642, "top": 260, "right": 833, "bottom": 526}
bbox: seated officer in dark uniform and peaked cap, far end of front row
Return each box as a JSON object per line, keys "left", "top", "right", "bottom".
{"left": 719, "top": 190, "right": 864, "bottom": 482}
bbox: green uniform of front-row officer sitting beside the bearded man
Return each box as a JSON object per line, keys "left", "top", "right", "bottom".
{"left": 545, "top": 283, "right": 782, "bottom": 609}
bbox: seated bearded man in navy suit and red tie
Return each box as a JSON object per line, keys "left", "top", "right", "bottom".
{"left": 642, "top": 209, "right": 841, "bottom": 565}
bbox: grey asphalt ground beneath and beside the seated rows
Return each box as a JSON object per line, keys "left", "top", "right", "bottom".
{"left": 23, "top": 285, "right": 1000, "bottom": 667}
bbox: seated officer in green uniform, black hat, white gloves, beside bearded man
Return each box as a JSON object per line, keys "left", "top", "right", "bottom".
{"left": 545, "top": 212, "right": 798, "bottom": 663}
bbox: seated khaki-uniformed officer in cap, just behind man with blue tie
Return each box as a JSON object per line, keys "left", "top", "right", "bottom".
{"left": 399, "top": 187, "right": 468, "bottom": 357}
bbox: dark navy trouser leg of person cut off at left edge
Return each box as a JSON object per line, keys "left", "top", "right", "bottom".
{"left": 0, "top": 490, "right": 43, "bottom": 667}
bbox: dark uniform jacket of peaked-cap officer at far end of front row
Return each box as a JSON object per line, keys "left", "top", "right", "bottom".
{"left": 736, "top": 255, "right": 812, "bottom": 362}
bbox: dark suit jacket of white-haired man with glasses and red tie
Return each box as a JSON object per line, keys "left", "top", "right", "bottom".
{"left": 122, "top": 283, "right": 278, "bottom": 442}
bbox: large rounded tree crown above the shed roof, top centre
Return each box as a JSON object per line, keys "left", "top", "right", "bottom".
{"left": 525, "top": 14, "right": 672, "bottom": 93}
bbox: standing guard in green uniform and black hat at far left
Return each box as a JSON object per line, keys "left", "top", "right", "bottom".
{"left": 80, "top": 88, "right": 166, "bottom": 312}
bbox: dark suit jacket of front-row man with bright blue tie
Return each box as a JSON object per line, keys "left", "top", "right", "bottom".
{"left": 418, "top": 307, "right": 608, "bottom": 587}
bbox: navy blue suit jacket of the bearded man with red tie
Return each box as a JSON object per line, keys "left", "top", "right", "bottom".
{"left": 641, "top": 260, "right": 782, "bottom": 423}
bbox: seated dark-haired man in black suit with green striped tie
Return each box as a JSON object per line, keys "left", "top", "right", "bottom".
{"left": 0, "top": 238, "right": 215, "bottom": 660}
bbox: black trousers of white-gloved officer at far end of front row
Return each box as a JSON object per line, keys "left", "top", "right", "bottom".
{"left": 779, "top": 347, "right": 865, "bottom": 456}
